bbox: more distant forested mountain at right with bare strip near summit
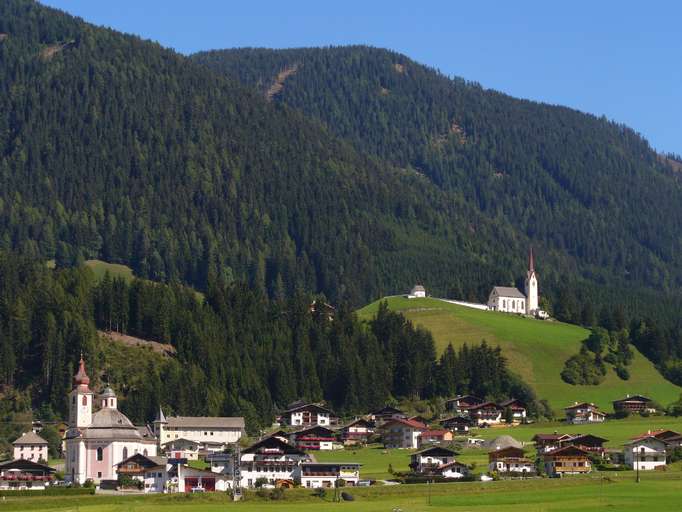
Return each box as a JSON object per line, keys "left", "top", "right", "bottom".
{"left": 193, "top": 46, "right": 682, "bottom": 320}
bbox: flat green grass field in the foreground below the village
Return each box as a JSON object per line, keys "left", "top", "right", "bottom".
{"left": 7, "top": 473, "right": 682, "bottom": 512}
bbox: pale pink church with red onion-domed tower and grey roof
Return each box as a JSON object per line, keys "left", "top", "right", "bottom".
{"left": 65, "top": 358, "right": 157, "bottom": 484}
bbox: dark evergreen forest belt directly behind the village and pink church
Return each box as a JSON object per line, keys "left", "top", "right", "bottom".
{"left": 0, "top": 252, "right": 534, "bottom": 430}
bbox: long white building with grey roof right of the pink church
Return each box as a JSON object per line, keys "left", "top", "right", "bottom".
{"left": 154, "top": 407, "right": 244, "bottom": 452}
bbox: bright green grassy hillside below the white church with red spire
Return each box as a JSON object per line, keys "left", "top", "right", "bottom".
{"left": 358, "top": 296, "right": 682, "bottom": 411}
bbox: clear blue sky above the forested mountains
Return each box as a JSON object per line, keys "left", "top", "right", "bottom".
{"left": 43, "top": 0, "right": 682, "bottom": 154}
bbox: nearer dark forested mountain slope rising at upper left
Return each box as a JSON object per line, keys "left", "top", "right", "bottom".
{"left": 0, "top": 0, "right": 527, "bottom": 305}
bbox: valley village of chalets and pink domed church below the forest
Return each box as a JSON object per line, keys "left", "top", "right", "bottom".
{"left": 0, "top": 352, "right": 682, "bottom": 498}
